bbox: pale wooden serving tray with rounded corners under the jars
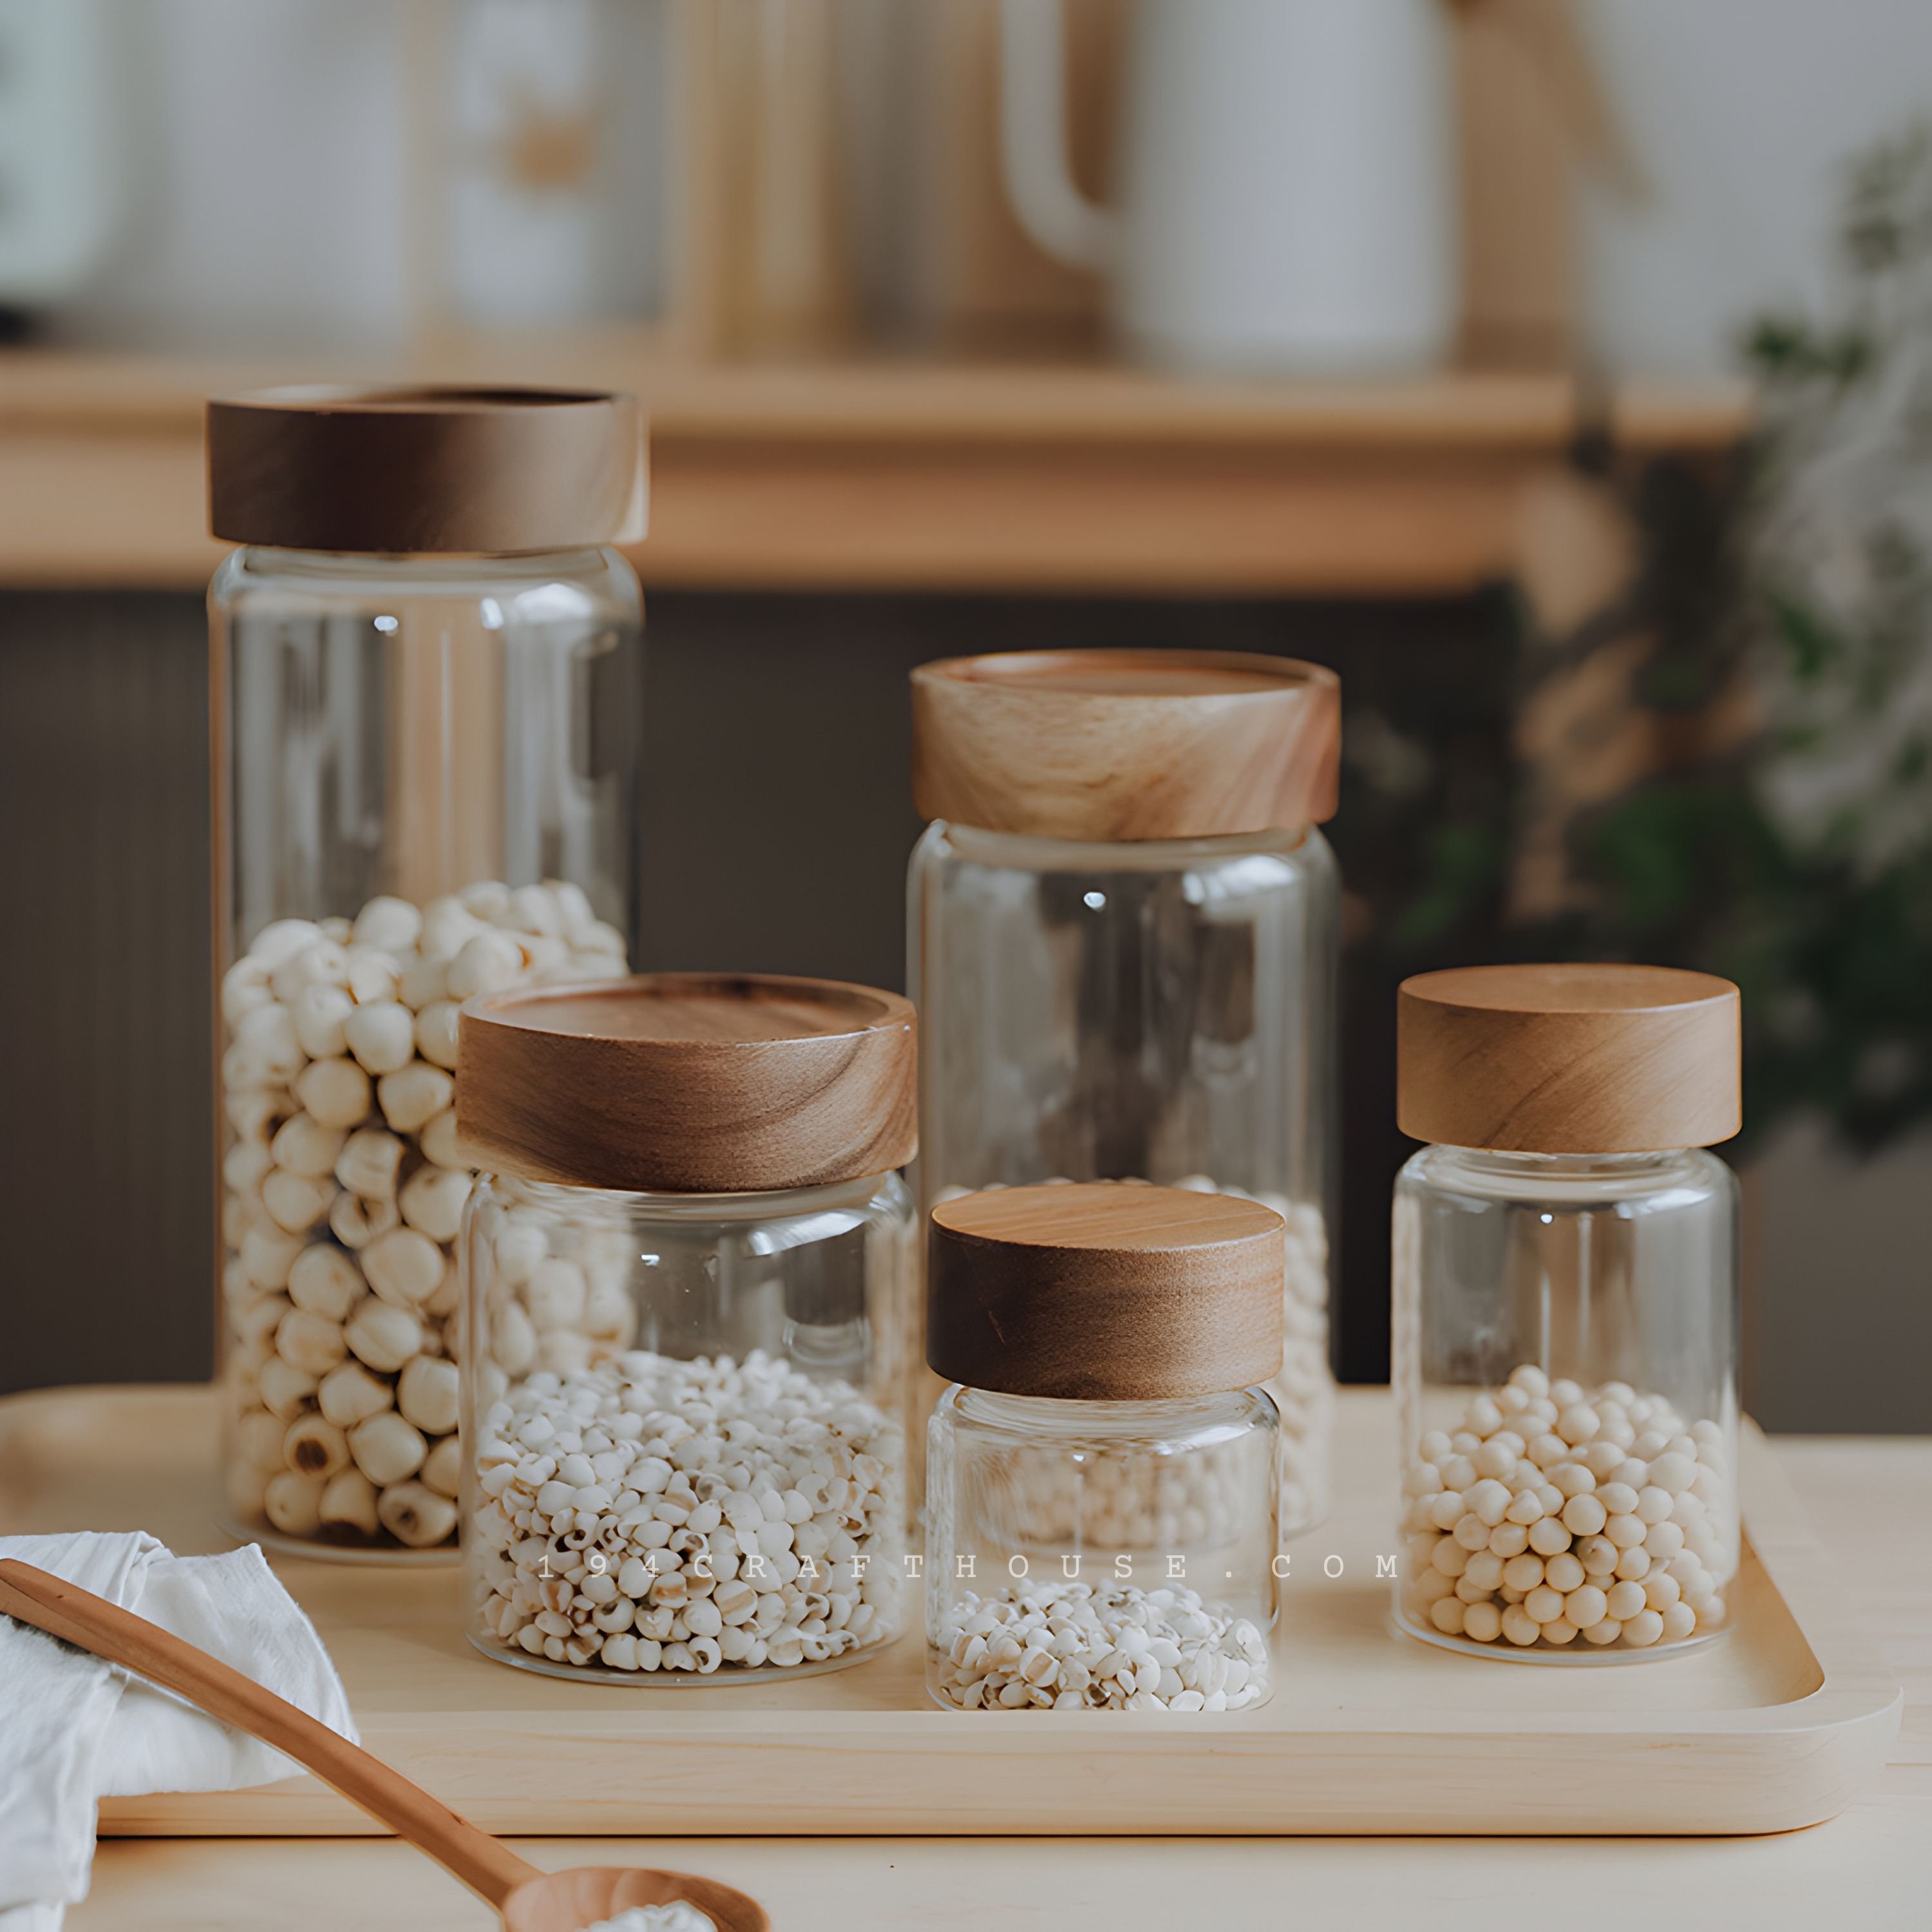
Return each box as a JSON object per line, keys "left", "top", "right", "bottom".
{"left": 0, "top": 1389, "right": 1901, "bottom": 1835}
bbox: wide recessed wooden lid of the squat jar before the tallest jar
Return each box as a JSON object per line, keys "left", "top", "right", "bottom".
{"left": 456, "top": 974, "right": 920, "bottom": 1194}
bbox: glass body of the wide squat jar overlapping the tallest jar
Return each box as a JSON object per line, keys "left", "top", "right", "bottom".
{"left": 462, "top": 1175, "right": 916, "bottom": 1685}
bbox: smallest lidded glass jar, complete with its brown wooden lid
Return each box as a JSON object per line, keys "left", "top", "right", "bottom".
{"left": 925, "top": 1182, "right": 1283, "bottom": 1712}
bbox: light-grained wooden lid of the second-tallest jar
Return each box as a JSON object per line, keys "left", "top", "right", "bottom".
{"left": 912, "top": 651, "right": 1341, "bottom": 842}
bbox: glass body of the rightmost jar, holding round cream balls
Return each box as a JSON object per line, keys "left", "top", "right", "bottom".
{"left": 1393, "top": 1148, "right": 1739, "bottom": 1662}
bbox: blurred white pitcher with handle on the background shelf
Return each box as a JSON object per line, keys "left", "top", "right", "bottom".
{"left": 1001, "top": 0, "right": 1457, "bottom": 375}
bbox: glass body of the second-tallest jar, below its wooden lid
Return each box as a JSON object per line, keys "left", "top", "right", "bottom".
{"left": 908, "top": 823, "right": 1341, "bottom": 1532}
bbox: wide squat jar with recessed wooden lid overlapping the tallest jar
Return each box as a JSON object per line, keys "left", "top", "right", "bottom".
{"left": 456, "top": 974, "right": 918, "bottom": 1685}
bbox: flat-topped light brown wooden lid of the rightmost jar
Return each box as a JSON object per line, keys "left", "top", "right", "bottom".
{"left": 1397, "top": 964, "right": 1743, "bottom": 1153}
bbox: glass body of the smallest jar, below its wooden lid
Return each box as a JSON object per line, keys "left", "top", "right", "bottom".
{"left": 925, "top": 1383, "right": 1281, "bottom": 1712}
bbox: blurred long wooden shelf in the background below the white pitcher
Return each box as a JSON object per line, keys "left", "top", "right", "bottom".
{"left": 0, "top": 338, "right": 1748, "bottom": 595}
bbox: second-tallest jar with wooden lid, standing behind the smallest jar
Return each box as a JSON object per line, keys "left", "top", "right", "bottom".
{"left": 908, "top": 651, "right": 1341, "bottom": 1532}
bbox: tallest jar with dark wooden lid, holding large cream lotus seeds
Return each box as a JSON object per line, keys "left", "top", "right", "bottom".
{"left": 209, "top": 390, "right": 643, "bottom": 1561}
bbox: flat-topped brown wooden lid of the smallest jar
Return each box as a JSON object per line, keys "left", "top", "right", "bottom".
{"left": 925, "top": 1180, "right": 1287, "bottom": 1403}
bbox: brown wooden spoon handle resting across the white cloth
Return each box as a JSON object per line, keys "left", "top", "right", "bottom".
{"left": 0, "top": 1557, "right": 543, "bottom": 1909}
